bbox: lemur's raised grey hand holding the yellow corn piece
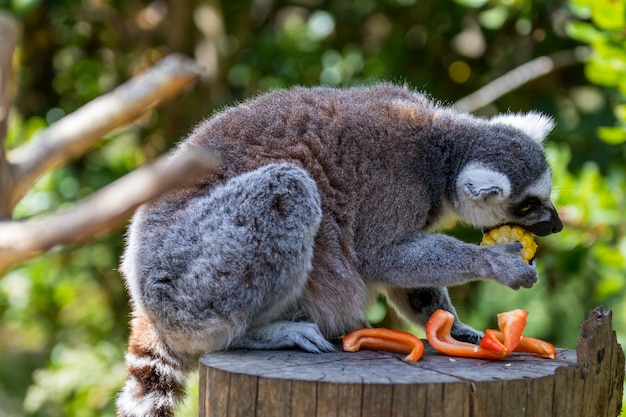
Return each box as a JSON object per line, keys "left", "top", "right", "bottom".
{"left": 482, "top": 242, "right": 537, "bottom": 290}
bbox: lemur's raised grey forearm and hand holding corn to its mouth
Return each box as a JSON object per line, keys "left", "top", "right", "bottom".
{"left": 365, "top": 234, "right": 537, "bottom": 289}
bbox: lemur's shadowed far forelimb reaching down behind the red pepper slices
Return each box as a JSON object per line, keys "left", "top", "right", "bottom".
{"left": 385, "top": 287, "right": 483, "bottom": 343}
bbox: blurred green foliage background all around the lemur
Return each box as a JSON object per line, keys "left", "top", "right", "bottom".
{"left": 0, "top": 0, "right": 626, "bottom": 417}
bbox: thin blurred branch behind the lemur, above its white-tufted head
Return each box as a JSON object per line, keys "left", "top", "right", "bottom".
{"left": 453, "top": 47, "right": 589, "bottom": 112}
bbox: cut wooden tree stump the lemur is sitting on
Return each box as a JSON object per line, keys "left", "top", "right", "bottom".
{"left": 200, "top": 307, "right": 624, "bottom": 417}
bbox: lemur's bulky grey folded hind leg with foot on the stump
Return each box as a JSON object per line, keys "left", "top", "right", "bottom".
{"left": 133, "top": 164, "right": 333, "bottom": 352}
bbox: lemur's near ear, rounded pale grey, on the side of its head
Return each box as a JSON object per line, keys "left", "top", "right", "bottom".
{"left": 456, "top": 163, "right": 511, "bottom": 201}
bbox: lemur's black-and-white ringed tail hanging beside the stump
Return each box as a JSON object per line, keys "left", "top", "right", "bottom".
{"left": 117, "top": 314, "right": 186, "bottom": 417}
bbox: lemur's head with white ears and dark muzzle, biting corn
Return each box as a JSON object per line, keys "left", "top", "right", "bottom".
{"left": 455, "top": 112, "right": 563, "bottom": 236}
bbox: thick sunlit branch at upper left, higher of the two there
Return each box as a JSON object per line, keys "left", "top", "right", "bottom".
{"left": 4, "top": 55, "right": 201, "bottom": 208}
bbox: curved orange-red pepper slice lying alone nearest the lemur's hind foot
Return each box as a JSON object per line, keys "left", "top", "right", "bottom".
{"left": 343, "top": 327, "right": 424, "bottom": 362}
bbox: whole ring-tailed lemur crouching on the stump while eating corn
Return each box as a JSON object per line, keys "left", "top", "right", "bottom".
{"left": 118, "top": 84, "right": 562, "bottom": 417}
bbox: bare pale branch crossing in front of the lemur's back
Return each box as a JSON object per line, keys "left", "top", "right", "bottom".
{"left": 0, "top": 149, "right": 219, "bottom": 277}
